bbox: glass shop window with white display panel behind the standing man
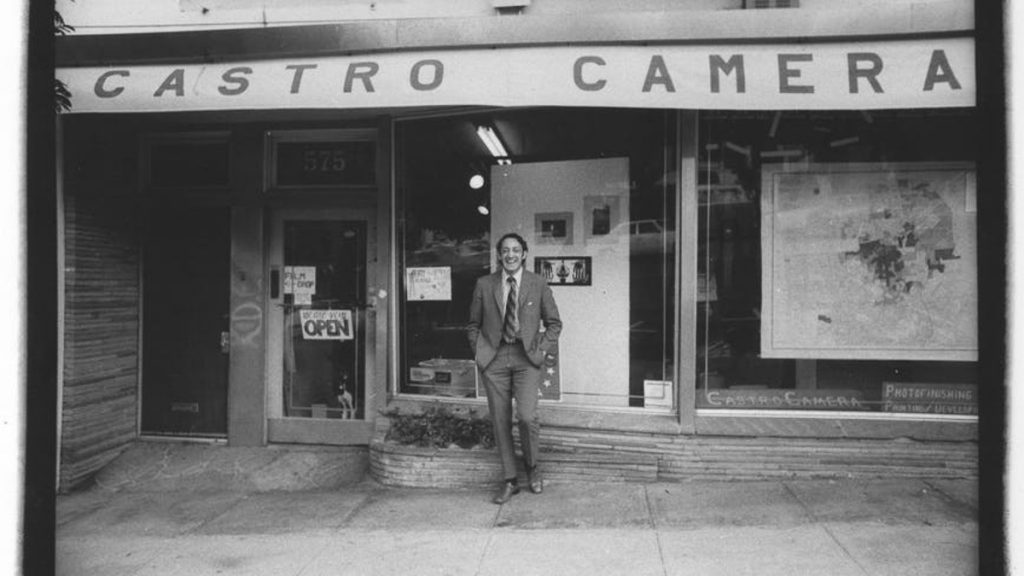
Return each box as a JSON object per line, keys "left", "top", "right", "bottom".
{"left": 396, "top": 109, "right": 676, "bottom": 410}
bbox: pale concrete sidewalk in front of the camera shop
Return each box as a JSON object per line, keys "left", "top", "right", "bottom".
{"left": 56, "top": 480, "right": 978, "bottom": 576}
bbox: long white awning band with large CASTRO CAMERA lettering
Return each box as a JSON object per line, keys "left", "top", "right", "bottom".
{"left": 56, "top": 38, "right": 976, "bottom": 113}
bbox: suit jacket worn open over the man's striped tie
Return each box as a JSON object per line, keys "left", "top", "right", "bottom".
{"left": 467, "top": 270, "right": 562, "bottom": 369}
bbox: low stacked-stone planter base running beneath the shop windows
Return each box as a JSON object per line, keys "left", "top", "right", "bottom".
{"left": 370, "top": 416, "right": 978, "bottom": 488}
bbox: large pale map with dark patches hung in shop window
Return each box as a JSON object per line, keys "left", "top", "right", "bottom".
{"left": 761, "top": 163, "right": 978, "bottom": 361}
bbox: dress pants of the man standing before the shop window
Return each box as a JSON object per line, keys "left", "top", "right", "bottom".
{"left": 483, "top": 340, "right": 541, "bottom": 479}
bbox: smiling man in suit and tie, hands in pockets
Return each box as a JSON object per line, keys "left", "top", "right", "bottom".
{"left": 468, "top": 234, "right": 562, "bottom": 504}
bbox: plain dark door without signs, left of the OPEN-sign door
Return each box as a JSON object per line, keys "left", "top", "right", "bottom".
{"left": 141, "top": 206, "right": 230, "bottom": 437}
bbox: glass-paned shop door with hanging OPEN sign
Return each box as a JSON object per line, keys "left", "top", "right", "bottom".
{"left": 267, "top": 210, "right": 377, "bottom": 444}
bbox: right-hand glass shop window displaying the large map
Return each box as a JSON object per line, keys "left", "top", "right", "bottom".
{"left": 695, "top": 110, "right": 978, "bottom": 414}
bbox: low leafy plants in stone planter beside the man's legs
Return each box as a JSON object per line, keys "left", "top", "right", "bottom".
{"left": 382, "top": 406, "right": 495, "bottom": 449}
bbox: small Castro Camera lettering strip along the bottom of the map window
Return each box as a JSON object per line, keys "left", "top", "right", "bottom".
{"left": 697, "top": 388, "right": 868, "bottom": 410}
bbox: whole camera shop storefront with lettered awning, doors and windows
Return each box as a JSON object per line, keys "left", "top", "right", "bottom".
{"left": 57, "top": 2, "right": 985, "bottom": 482}
